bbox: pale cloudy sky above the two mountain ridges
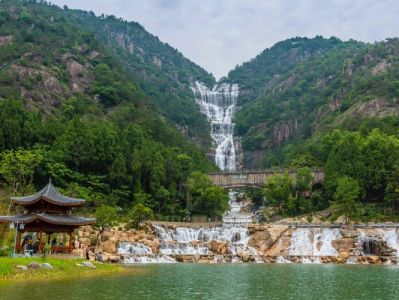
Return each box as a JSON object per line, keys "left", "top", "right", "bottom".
{"left": 51, "top": 0, "right": 399, "bottom": 78}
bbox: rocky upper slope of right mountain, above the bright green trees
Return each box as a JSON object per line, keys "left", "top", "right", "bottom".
{"left": 228, "top": 36, "right": 399, "bottom": 168}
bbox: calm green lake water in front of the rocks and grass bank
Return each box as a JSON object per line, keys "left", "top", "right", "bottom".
{"left": 0, "top": 264, "right": 399, "bottom": 300}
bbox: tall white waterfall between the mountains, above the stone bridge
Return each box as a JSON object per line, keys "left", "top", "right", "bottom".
{"left": 191, "top": 81, "right": 239, "bottom": 171}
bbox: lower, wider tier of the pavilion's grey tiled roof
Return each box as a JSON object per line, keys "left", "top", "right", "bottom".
{"left": 0, "top": 213, "right": 96, "bottom": 226}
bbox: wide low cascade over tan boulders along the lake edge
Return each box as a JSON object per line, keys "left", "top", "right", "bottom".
{"left": 118, "top": 224, "right": 399, "bottom": 264}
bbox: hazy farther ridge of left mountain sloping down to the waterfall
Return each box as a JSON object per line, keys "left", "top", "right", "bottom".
{"left": 70, "top": 9, "right": 215, "bottom": 147}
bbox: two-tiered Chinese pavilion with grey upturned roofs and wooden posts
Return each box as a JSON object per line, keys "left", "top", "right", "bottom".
{"left": 0, "top": 179, "right": 95, "bottom": 253}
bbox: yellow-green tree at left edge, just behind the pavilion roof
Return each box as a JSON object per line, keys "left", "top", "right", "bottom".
{"left": 0, "top": 149, "right": 43, "bottom": 195}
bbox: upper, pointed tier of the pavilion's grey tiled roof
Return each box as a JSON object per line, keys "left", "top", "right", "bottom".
{"left": 11, "top": 180, "right": 85, "bottom": 206}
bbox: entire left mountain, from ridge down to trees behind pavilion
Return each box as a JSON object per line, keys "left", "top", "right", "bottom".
{"left": 0, "top": 0, "right": 215, "bottom": 215}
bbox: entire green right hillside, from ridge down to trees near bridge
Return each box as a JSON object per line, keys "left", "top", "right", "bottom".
{"left": 228, "top": 37, "right": 399, "bottom": 216}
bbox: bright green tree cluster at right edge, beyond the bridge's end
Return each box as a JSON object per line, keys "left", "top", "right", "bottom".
{"left": 322, "top": 129, "right": 399, "bottom": 203}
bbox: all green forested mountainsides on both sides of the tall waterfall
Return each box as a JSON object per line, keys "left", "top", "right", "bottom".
{"left": 0, "top": 0, "right": 399, "bottom": 225}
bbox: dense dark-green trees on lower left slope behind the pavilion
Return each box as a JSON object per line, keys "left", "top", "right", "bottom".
{"left": 0, "top": 100, "right": 217, "bottom": 217}
